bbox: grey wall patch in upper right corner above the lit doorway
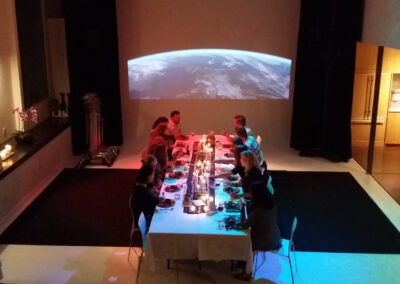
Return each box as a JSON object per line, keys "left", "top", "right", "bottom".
{"left": 362, "top": 0, "right": 400, "bottom": 48}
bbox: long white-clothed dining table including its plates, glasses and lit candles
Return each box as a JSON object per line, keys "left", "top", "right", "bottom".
{"left": 147, "top": 133, "right": 252, "bottom": 271}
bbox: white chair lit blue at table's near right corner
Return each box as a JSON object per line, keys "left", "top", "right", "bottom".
{"left": 253, "top": 217, "right": 297, "bottom": 284}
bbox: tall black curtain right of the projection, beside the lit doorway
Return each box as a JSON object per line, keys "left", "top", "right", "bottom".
{"left": 290, "top": 0, "right": 364, "bottom": 161}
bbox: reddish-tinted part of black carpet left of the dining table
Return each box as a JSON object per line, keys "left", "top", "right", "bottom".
{"left": 0, "top": 169, "right": 141, "bottom": 246}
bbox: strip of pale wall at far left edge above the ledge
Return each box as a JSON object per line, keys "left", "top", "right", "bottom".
{"left": 0, "top": 0, "right": 21, "bottom": 143}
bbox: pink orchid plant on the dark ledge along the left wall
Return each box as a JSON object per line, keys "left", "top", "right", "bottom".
{"left": 12, "top": 107, "right": 38, "bottom": 142}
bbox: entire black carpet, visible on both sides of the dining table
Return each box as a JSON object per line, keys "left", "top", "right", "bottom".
{"left": 0, "top": 169, "right": 400, "bottom": 253}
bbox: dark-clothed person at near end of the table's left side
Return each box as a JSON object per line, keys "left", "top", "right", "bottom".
{"left": 131, "top": 164, "right": 158, "bottom": 232}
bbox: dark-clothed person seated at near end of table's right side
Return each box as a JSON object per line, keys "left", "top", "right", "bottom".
{"left": 234, "top": 182, "right": 282, "bottom": 280}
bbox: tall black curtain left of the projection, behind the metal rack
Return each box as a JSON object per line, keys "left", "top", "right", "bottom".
{"left": 64, "top": 0, "right": 123, "bottom": 154}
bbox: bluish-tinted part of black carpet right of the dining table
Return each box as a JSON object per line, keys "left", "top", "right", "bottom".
{"left": 272, "top": 171, "right": 400, "bottom": 253}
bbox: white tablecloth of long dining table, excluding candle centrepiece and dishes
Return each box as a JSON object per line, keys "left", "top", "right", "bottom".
{"left": 146, "top": 135, "right": 253, "bottom": 273}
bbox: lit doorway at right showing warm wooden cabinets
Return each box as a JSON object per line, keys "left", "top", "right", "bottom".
{"left": 351, "top": 43, "right": 400, "bottom": 204}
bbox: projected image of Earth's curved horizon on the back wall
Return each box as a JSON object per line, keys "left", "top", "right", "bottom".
{"left": 128, "top": 49, "right": 291, "bottom": 100}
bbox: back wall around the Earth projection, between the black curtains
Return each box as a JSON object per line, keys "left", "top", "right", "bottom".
{"left": 116, "top": 0, "right": 300, "bottom": 151}
